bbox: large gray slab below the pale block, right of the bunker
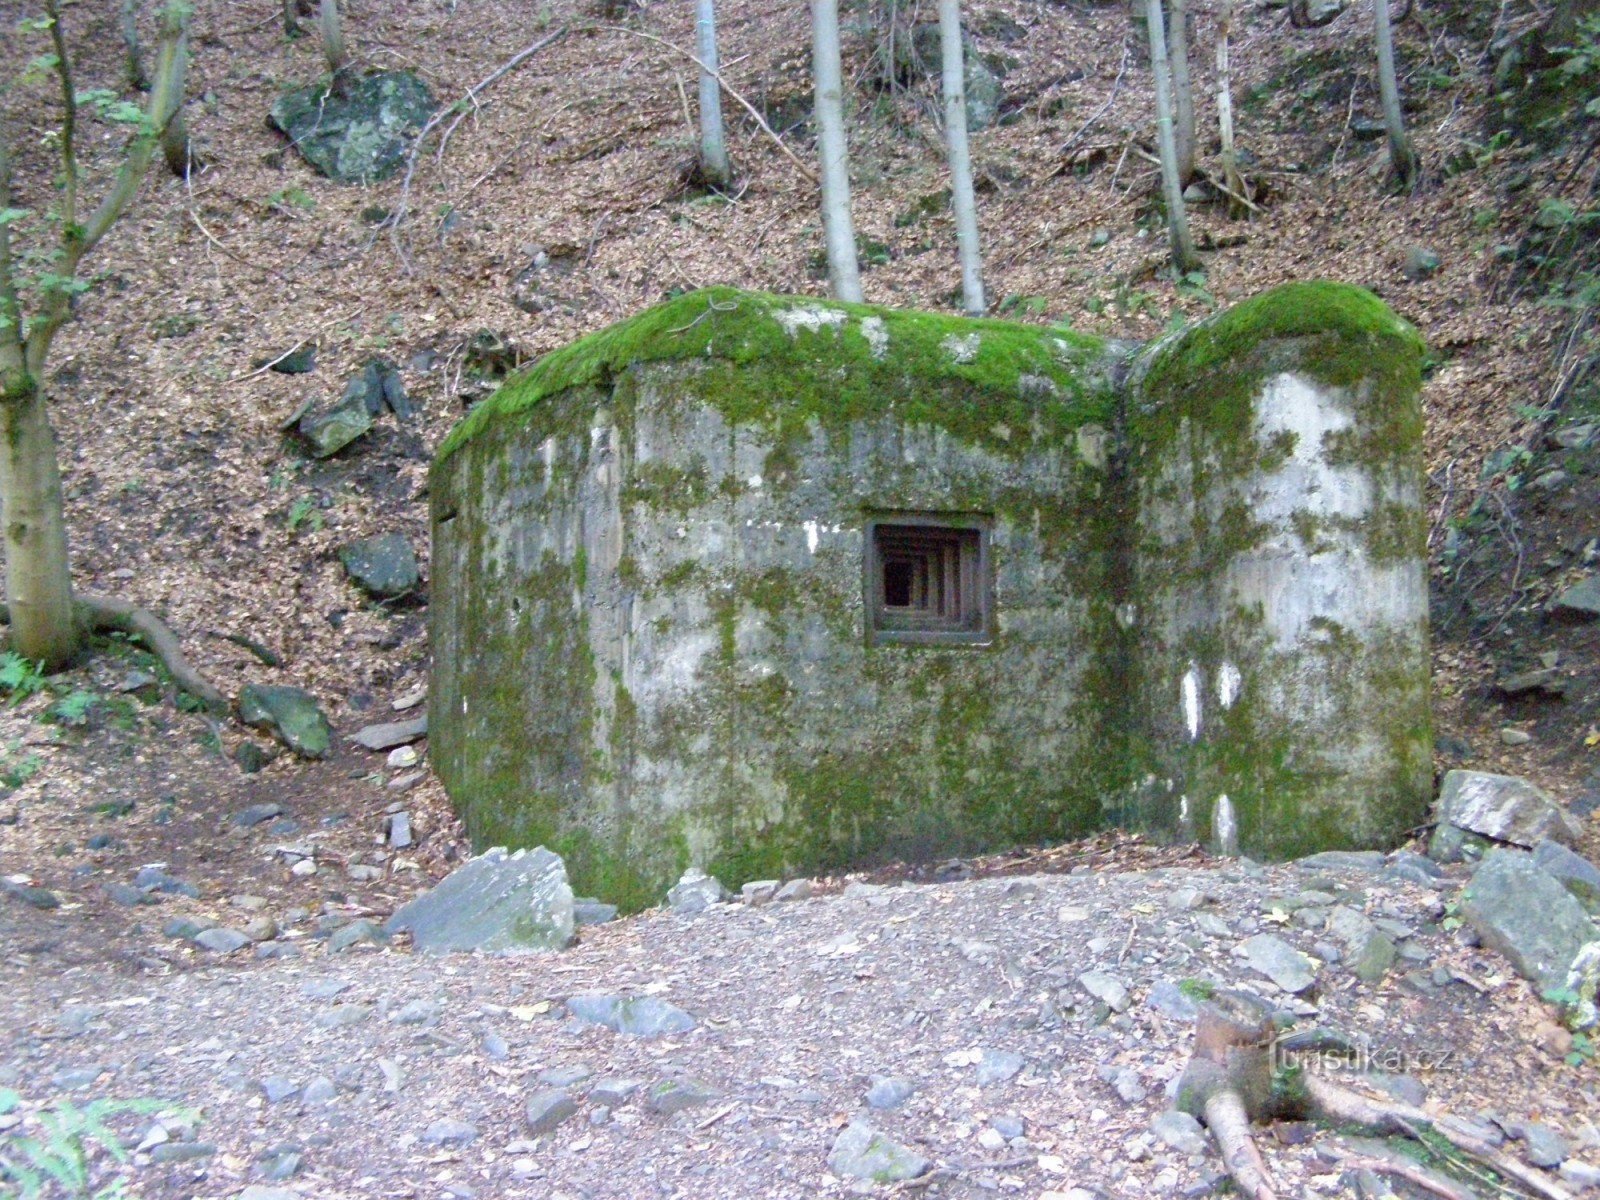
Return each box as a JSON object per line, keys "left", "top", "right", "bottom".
{"left": 1461, "top": 850, "right": 1595, "bottom": 989}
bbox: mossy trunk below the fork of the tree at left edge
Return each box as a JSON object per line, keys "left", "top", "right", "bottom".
{"left": 0, "top": 382, "right": 80, "bottom": 670}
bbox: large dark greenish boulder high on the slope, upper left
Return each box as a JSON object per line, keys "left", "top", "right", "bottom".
{"left": 270, "top": 70, "right": 435, "bottom": 184}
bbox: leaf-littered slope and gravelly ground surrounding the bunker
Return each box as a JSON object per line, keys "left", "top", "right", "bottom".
{"left": 0, "top": 0, "right": 1600, "bottom": 1197}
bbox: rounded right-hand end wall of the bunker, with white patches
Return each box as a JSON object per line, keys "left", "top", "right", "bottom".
{"left": 1123, "top": 283, "right": 1432, "bottom": 858}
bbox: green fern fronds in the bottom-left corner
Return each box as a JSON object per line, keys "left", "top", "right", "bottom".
{"left": 0, "top": 1088, "right": 194, "bottom": 1200}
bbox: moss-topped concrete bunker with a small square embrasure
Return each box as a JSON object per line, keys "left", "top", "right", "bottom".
{"left": 430, "top": 283, "right": 1430, "bottom": 907}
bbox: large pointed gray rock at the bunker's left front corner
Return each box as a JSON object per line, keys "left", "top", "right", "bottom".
{"left": 384, "top": 846, "right": 573, "bottom": 954}
